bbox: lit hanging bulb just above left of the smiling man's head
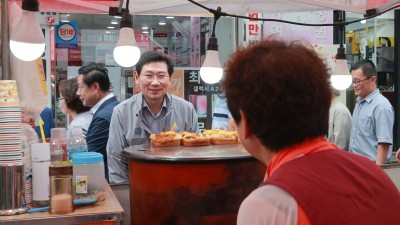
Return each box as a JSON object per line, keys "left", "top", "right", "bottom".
{"left": 113, "top": 11, "right": 140, "bottom": 67}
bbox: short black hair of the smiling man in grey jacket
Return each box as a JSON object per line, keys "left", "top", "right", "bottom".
{"left": 135, "top": 51, "right": 174, "bottom": 76}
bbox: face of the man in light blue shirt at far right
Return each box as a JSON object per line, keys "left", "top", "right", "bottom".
{"left": 351, "top": 68, "right": 376, "bottom": 99}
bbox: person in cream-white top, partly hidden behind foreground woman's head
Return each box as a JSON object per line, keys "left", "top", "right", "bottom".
{"left": 328, "top": 86, "right": 351, "bottom": 150}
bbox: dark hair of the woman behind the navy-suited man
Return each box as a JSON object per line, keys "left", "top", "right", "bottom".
{"left": 58, "top": 78, "right": 91, "bottom": 113}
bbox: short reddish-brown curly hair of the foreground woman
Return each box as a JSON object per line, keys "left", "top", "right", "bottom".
{"left": 223, "top": 39, "right": 331, "bottom": 151}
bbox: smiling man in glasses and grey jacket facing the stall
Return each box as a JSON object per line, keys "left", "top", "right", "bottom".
{"left": 107, "top": 51, "right": 199, "bottom": 183}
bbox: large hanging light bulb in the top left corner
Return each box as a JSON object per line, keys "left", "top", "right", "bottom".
{"left": 10, "top": 0, "right": 45, "bottom": 61}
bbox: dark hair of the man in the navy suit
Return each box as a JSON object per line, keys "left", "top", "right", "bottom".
{"left": 78, "top": 63, "right": 111, "bottom": 92}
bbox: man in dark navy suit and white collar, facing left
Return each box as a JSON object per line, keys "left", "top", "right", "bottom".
{"left": 76, "top": 64, "right": 119, "bottom": 181}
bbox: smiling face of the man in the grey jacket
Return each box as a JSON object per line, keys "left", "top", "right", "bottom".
{"left": 135, "top": 62, "right": 171, "bottom": 103}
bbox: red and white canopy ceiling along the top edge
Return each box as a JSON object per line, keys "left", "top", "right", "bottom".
{"left": 9, "top": 0, "right": 400, "bottom": 16}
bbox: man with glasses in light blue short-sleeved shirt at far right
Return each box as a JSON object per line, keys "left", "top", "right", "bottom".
{"left": 349, "top": 60, "right": 394, "bottom": 165}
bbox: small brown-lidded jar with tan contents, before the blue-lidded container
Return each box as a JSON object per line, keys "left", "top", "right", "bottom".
{"left": 49, "top": 164, "right": 74, "bottom": 214}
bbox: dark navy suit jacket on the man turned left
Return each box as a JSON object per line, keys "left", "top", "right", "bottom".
{"left": 86, "top": 97, "right": 119, "bottom": 181}
